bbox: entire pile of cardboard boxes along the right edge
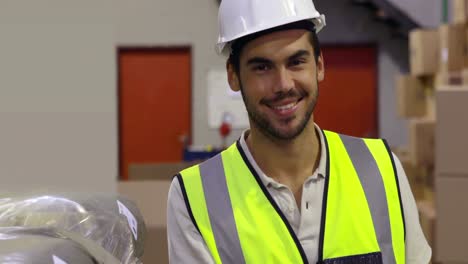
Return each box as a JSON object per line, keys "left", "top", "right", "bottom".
{"left": 396, "top": 0, "right": 468, "bottom": 263}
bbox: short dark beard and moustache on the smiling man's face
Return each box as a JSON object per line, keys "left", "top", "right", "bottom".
{"left": 240, "top": 82, "right": 318, "bottom": 141}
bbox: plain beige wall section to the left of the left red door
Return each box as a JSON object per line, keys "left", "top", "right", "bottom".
{"left": 0, "top": 0, "right": 117, "bottom": 192}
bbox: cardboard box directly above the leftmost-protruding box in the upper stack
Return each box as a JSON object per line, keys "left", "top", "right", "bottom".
{"left": 409, "top": 29, "right": 440, "bottom": 76}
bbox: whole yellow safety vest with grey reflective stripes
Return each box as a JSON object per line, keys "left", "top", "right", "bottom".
{"left": 177, "top": 131, "right": 405, "bottom": 264}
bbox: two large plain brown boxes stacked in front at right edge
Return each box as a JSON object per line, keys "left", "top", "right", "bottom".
{"left": 435, "top": 86, "right": 468, "bottom": 263}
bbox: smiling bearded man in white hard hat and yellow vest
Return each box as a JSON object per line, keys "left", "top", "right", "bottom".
{"left": 168, "top": 0, "right": 431, "bottom": 264}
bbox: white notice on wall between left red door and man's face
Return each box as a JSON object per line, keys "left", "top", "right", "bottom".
{"left": 207, "top": 70, "right": 249, "bottom": 129}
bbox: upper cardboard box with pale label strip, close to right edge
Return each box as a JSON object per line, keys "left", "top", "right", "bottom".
{"left": 438, "top": 24, "right": 466, "bottom": 72}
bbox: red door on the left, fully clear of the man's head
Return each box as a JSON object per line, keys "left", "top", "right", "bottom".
{"left": 119, "top": 48, "right": 191, "bottom": 179}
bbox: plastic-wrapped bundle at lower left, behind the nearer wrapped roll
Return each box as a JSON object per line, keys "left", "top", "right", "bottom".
{"left": 0, "top": 194, "right": 146, "bottom": 264}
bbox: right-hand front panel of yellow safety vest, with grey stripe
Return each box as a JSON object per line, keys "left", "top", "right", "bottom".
{"left": 322, "top": 131, "right": 405, "bottom": 264}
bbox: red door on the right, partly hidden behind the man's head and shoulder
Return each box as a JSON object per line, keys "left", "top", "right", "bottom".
{"left": 314, "top": 46, "right": 378, "bottom": 137}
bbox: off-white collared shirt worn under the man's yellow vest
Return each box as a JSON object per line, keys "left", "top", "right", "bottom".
{"left": 167, "top": 125, "right": 432, "bottom": 264}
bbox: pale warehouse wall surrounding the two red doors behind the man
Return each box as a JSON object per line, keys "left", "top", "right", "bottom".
{"left": 0, "top": 0, "right": 428, "bottom": 191}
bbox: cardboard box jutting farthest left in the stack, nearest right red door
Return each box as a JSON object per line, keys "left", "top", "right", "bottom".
{"left": 397, "top": 75, "right": 426, "bottom": 118}
